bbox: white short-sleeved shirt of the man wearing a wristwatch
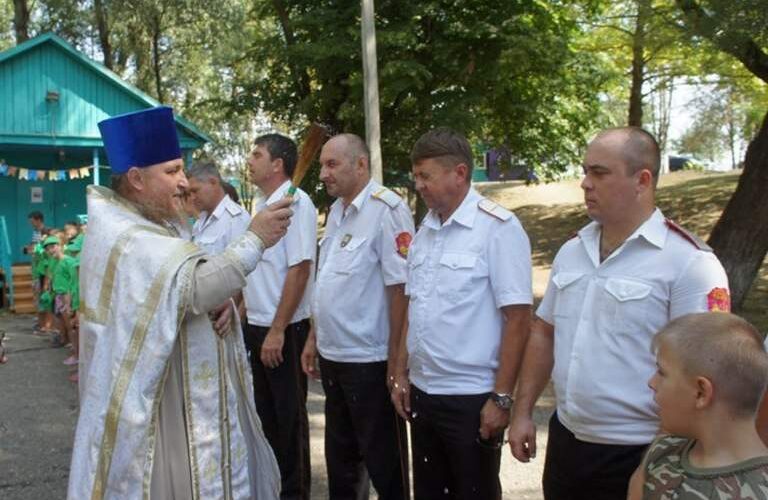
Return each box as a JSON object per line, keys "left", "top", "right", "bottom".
{"left": 407, "top": 189, "right": 533, "bottom": 395}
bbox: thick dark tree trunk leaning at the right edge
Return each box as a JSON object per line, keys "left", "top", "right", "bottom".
{"left": 709, "top": 113, "right": 768, "bottom": 311}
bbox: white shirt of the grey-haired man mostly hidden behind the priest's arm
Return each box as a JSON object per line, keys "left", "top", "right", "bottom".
{"left": 192, "top": 195, "right": 251, "bottom": 254}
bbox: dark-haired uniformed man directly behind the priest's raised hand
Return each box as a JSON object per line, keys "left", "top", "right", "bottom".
{"left": 244, "top": 134, "right": 317, "bottom": 500}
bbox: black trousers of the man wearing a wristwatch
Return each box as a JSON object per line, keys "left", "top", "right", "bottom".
{"left": 411, "top": 385, "right": 501, "bottom": 500}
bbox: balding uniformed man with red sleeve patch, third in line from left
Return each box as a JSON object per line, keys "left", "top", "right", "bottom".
{"left": 294, "top": 134, "right": 413, "bottom": 500}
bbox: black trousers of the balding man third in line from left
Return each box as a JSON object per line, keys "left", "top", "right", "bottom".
{"left": 320, "top": 357, "right": 410, "bottom": 500}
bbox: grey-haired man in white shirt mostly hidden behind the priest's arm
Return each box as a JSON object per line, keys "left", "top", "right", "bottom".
{"left": 187, "top": 162, "right": 251, "bottom": 254}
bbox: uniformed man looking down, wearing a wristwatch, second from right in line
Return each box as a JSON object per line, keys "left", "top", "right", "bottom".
{"left": 392, "top": 128, "right": 533, "bottom": 500}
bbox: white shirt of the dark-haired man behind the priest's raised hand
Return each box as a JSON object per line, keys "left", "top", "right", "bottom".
{"left": 243, "top": 181, "right": 317, "bottom": 327}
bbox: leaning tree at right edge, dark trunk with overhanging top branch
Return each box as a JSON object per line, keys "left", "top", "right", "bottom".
{"left": 676, "top": 0, "right": 768, "bottom": 309}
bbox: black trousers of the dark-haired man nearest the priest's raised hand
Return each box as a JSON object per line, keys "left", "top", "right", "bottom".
{"left": 245, "top": 319, "right": 311, "bottom": 500}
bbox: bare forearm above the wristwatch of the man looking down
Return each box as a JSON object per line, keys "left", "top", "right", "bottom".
{"left": 494, "top": 305, "right": 531, "bottom": 394}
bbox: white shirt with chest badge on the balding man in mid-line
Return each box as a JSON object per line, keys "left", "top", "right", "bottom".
{"left": 312, "top": 181, "right": 414, "bottom": 363}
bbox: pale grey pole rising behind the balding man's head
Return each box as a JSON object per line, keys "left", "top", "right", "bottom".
{"left": 361, "top": 0, "right": 384, "bottom": 182}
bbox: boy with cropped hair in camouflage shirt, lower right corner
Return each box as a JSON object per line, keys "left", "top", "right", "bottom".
{"left": 628, "top": 313, "right": 768, "bottom": 500}
